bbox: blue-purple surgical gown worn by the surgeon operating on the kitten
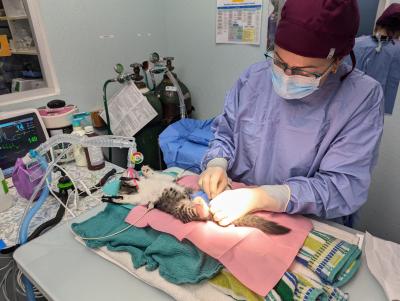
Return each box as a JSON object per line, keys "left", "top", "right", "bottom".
{"left": 202, "top": 62, "right": 383, "bottom": 219}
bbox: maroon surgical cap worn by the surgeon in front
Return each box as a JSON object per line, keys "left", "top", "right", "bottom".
{"left": 275, "top": 0, "right": 360, "bottom": 58}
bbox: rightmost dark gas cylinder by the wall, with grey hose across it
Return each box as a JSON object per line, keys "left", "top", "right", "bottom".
{"left": 155, "top": 57, "right": 193, "bottom": 124}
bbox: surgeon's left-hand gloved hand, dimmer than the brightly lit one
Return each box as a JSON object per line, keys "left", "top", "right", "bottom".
{"left": 199, "top": 166, "right": 228, "bottom": 200}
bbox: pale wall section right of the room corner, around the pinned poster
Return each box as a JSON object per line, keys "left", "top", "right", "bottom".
{"left": 166, "top": 0, "right": 268, "bottom": 118}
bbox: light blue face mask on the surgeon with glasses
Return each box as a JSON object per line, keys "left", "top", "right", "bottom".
{"left": 271, "top": 65, "right": 321, "bottom": 99}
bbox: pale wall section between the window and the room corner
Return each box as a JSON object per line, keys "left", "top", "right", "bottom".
{"left": 0, "top": 0, "right": 166, "bottom": 111}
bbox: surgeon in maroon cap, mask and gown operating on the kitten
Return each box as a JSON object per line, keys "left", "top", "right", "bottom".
{"left": 199, "top": 0, "right": 383, "bottom": 226}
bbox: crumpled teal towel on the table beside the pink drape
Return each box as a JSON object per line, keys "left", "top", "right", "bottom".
{"left": 72, "top": 204, "right": 222, "bottom": 284}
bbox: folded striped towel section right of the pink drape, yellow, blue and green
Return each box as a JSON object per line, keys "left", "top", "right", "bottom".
{"left": 296, "top": 230, "right": 361, "bottom": 287}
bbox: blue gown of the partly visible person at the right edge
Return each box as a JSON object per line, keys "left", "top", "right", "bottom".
{"left": 348, "top": 36, "right": 400, "bottom": 114}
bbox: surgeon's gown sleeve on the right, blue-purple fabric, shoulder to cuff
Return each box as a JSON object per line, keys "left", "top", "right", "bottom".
{"left": 285, "top": 86, "right": 384, "bottom": 219}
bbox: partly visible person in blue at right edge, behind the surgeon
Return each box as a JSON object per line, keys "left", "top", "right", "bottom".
{"left": 347, "top": 3, "right": 400, "bottom": 114}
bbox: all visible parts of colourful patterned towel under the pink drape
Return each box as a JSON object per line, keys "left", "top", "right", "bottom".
{"left": 210, "top": 230, "right": 361, "bottom": 301}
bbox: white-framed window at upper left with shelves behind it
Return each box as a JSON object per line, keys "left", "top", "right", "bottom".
{"left": 0, "top": 0, "right": 59, "bottom": 106}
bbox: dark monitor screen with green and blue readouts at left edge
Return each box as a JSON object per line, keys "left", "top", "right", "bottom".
{"left": 0, "top": 113, "right": 46, "bottom": 176}
